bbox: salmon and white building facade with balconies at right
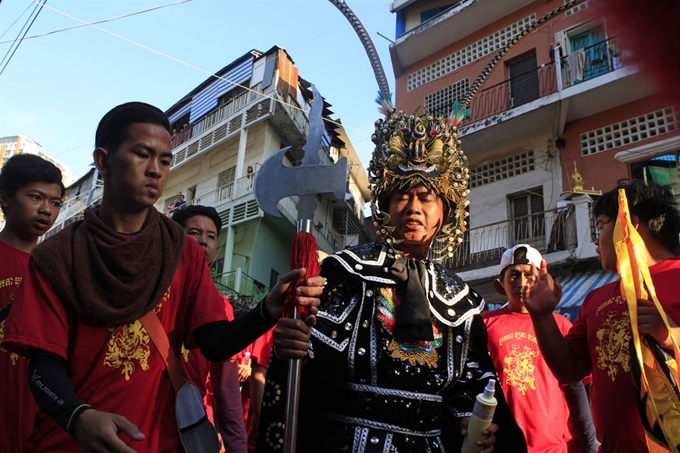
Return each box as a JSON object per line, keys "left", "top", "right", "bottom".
{"left": 390, "top": 0, "right": 680, "bottom": 316}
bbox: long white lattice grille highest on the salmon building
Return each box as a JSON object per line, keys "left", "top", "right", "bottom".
{"left": 406, "top": 14, "right": 536, "bottom": 91}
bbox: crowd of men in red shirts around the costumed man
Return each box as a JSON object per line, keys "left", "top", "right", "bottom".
{"left": 0, "top": 96, "right": 680, "bottom": 453}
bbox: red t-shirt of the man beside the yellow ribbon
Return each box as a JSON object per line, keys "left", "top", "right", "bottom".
{"left": 567, "top": 258, "right": 680, "bottom": 453}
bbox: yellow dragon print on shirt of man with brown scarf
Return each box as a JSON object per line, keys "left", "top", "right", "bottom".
{"left": 104, "top": 288, "right": 170, "bottom": 381}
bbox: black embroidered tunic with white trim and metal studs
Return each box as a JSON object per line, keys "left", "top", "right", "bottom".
{"left": 257, "top": 244, "right": 526, "bottom": 453}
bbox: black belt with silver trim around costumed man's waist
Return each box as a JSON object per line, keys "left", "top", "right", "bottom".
{"left": 326, "top": 384, "right": 445, "bottom": 437}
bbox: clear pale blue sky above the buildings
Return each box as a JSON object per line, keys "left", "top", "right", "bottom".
{"left": 0, "top": 0, "right": 396, "bottom": 182}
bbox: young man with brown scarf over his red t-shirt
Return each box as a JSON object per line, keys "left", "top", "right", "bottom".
{"left": 4, "top": 102, "right": 324, "bottom": 453}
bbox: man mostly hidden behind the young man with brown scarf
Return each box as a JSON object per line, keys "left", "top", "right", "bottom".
{"left": 172, "top": 205, "right": 248, "bottom": 453}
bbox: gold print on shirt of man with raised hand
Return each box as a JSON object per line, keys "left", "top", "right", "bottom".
{"left": 595, "top": 311, "right": 631, "bottom": 381}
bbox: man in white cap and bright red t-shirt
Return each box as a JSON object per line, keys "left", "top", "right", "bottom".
{"left": 482, "top": 244, "right": 597, "bottom": 453}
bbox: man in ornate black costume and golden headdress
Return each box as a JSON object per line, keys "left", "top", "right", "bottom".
{"left": 257, "top": 109, "right": 526, "bottom": 453}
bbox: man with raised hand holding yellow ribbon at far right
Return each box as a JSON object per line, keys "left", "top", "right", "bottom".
{"left": 524, "top": 180, "right": 680, "bottom": 453}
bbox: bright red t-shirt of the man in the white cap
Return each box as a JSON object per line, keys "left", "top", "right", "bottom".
{"left": 482, "top": 307, "right": 571, "bottom": 453}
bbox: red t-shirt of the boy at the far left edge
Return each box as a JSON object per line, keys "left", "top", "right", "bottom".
{"left": 0, "top": 241, "right": 38, "bottom": 453}
